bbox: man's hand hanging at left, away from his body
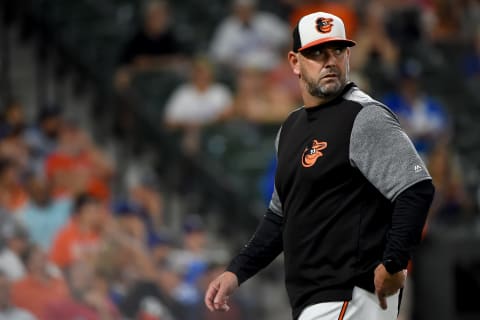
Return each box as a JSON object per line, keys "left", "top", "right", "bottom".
{"left": 205, "top": 271, "right": 238, "bottom": 311}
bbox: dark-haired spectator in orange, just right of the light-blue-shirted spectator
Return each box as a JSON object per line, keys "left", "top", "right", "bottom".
{"left": 50, "top": 194, "right": 102, "bottom": 269}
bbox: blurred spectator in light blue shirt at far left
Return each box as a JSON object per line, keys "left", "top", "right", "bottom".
{"left": 18, "top": 174, "right": 72, "bottom": 252}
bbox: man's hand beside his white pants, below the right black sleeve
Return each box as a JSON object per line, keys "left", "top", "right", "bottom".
{"left": 374, "top": 264, "right": 407, "bottom": 310}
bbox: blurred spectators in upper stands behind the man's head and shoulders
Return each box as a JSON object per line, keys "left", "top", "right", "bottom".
{"left": 115, "top": 0, "right": 480, "bottom": 223}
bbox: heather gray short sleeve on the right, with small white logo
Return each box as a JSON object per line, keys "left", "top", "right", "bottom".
{"left": 350, "top": 105, "right": 431, "bottom": 202}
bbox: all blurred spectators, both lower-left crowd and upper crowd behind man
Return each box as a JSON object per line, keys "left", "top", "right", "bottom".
{"left": 0, "top": 0, "right": 480, "bottom": 320}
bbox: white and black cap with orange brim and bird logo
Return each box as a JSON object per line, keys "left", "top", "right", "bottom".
{"left": 293, "top": 11, "right": 356, "bottom": 52}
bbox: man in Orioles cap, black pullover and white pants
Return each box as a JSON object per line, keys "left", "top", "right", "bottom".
{"left": 205, "top": 12, "right": 434, "bottom": 320}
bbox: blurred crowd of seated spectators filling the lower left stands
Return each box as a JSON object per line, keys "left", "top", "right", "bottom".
{"left": 0, "top": 101, "right": 248, "bottom": 320}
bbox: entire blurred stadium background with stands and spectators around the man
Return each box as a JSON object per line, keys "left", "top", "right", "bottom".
{"left": 0, "top": 0, "right": 480, "bottom": 320}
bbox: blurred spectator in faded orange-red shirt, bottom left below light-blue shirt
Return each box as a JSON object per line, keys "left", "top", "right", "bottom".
{"left": 12, "top": 245, "right": 69, "bottom": 320}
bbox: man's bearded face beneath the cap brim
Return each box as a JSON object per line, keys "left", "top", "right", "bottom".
{"left": 294, "top": 44, "right": 350, "bottom": 98}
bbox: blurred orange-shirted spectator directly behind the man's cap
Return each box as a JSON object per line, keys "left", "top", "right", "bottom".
{"left": 290, "top": 1, "right": 358, "bottom": 39}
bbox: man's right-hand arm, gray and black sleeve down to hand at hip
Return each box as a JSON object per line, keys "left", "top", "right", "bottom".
{"left": 350, "top": 105, "right": 434, "bottom": 308}
